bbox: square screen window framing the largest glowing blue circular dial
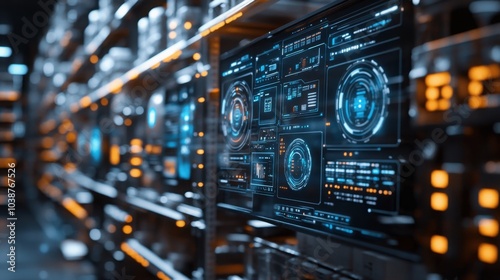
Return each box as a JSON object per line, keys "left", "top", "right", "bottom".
{"left": 327, "top": 49, "right": 402, "bottom": 146}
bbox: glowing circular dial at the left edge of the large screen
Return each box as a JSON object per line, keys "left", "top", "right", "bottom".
{"left": 221, "top": 81, "right": 251, "bottom": 151}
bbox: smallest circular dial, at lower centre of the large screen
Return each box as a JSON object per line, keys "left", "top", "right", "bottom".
{"left": 285, "top": 138, "right": 312, "bottom": 191}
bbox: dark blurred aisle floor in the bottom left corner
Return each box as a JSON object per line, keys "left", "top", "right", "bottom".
{"left": 0, "top": 208, "right": 97, "bottom": 280}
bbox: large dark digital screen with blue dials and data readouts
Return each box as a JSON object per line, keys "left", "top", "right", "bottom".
{"left": 218, "top": 1, "right": 416, "bottom": 258}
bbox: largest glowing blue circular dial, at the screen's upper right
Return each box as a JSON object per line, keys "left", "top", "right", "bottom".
{"left": 336, "top": 60, "right": 389, "bottom": 143}
